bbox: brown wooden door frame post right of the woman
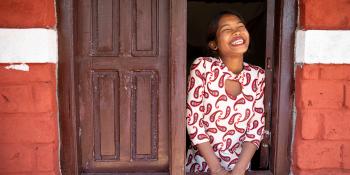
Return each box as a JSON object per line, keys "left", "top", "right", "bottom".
{"left": 270, "top": 0, "right": 298, "bottom": 175}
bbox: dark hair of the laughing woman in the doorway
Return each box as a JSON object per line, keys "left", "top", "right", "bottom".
{"left": 207, "top": 10, "right": 246, "bottom": 56}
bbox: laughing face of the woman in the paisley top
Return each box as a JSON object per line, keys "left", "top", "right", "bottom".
{"left": 216, "top": 15, "right": 249, "bottom": 57}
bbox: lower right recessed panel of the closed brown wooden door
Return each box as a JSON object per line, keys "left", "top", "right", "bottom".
{"left": 131, "top": 71, "right": 159, "bottom": 160}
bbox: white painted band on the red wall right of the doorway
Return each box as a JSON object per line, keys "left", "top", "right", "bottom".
{"left": 295, "top": 30, "right": 350, "bottom": 64}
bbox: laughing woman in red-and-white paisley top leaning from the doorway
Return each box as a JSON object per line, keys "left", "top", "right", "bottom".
{"left": 186, "top": 11, "right": 265, "bottom": 174}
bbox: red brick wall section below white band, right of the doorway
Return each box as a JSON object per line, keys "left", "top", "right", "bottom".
{"left": 294, "top": 64, "right": 350, "bottom": 174}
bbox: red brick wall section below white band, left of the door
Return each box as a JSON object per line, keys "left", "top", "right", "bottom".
{"left": 0, "top": 64, "right": 58, "bottom": 174}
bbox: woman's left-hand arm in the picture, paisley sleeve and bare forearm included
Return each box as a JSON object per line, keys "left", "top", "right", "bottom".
{"left": 186, "top": 58, "right": 228, "bottom": 175}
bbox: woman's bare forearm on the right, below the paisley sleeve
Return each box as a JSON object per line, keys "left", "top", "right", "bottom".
{"left": 230, "top": 142, "right": 256, "bottom": 175}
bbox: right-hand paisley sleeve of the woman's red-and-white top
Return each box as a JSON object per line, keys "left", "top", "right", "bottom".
{"left": 244, "top": 70, "right": 265, "bottom": 149}
